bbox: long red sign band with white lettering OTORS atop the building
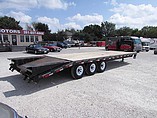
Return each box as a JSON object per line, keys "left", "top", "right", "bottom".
{"left": 0, "top": 29, "right": 44, "bottom": 35}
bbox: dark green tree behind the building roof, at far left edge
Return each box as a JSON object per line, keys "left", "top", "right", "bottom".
{"left": 0, "top": 16, "right": 22, "bottom": 30}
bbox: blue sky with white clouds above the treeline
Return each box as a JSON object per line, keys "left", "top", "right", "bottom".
{"left": 0, "top": 0, "right": 157, "bottom": 33}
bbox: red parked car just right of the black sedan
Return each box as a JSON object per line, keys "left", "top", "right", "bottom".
{"left": 43, "top": 43, "right": 62, "bottom": 52}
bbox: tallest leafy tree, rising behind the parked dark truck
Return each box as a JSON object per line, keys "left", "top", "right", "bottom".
{"left": 101, "top": 21, "right": 116, "bottom": 37}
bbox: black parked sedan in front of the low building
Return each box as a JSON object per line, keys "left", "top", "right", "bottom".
{"left": 26, "top": 44, "right": 49, "bottom": 54}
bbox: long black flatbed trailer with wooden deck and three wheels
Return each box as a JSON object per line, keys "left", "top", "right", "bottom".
{"left": 9, "top": 51, "right": 136, "bottom": 82}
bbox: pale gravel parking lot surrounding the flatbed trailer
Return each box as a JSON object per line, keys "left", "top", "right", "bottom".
{"left": 0, "top": 47, "right": 157, "bottom": 118}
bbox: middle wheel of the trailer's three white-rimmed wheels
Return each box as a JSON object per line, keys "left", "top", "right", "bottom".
{"left": 86, "top": 62, "right": 97, "bottom": 75}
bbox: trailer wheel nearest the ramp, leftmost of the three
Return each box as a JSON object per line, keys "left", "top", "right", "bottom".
{"left": 71, "top": 65, "right": 84, "bottom": 79}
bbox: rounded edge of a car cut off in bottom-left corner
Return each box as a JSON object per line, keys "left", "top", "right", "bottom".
{"left": 0, "top": 103, "right": 22, "bottom": 118}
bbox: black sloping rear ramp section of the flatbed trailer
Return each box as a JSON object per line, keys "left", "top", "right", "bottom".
{"left": 9, "top": 56, "right": 71, "bottom": 81}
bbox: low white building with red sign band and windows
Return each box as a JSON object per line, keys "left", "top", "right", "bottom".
{"left": 0, "top": 29, "right": 44, "bottom": 46}
